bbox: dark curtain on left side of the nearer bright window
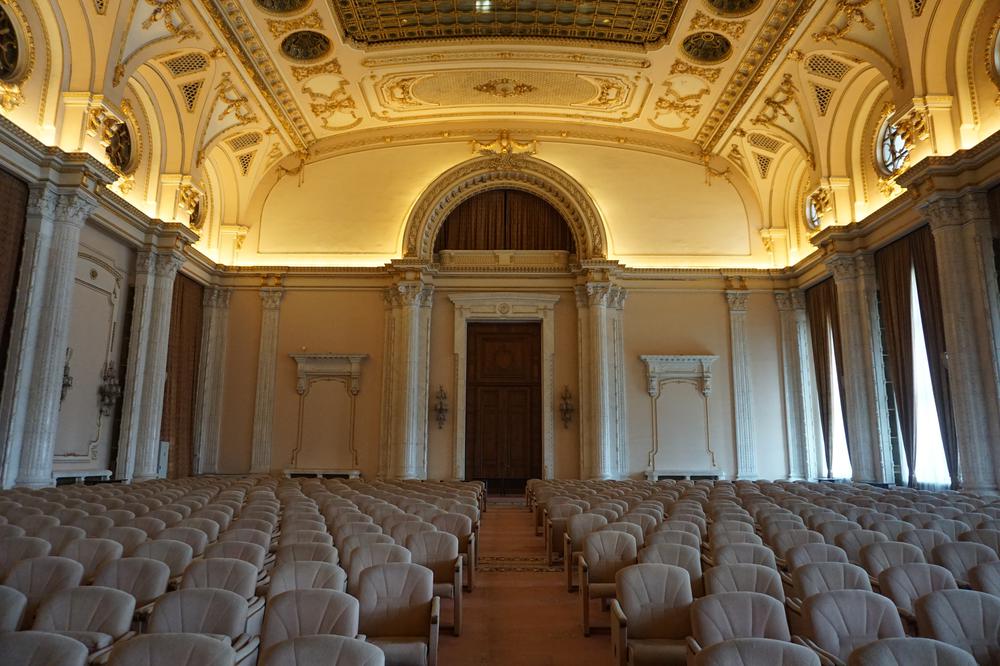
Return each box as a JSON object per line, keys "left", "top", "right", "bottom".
{"left": 875, "top": 237, "right": 916, "bottom": 487}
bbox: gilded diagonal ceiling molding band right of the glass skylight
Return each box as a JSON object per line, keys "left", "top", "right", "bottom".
{"left": 695, "top": 0, "right": 816, "bottom": 151}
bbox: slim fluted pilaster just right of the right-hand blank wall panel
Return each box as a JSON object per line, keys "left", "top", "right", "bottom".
{"left": 726, "top": 289, "right": 757, "bottom": 480}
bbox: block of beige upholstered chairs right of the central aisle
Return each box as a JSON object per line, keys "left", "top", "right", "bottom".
{"left": 528, "top": 474, "right": 1000, "bottom": 664}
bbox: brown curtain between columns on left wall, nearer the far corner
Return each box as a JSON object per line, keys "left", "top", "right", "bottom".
{"left": 160, "top": 275, "right": 204, "bottom": 479}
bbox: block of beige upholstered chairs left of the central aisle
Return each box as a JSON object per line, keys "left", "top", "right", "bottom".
{"left": 0, "top": 477, "right": 483, "bottom": 664}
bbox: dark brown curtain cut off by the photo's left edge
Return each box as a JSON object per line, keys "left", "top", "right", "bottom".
{"left": 0, "top": 170, "right": 28, "bottom": 390}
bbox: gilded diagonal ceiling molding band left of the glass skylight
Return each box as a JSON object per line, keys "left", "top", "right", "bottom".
{"left": 201, "top": 0, "right": 316, "bottom": 150}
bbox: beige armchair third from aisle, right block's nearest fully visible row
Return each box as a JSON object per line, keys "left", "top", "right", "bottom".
{"left": 799, "top": 590, "right": 905, "bottom": 666}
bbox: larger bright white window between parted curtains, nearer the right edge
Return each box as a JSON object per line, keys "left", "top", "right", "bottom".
{"left": 902, "top": 271, "right": 951, "bottom": 486}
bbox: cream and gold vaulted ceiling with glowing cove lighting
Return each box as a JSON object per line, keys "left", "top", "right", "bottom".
{"left": 0, "top": 0, "right": 1000, "bottom": 267}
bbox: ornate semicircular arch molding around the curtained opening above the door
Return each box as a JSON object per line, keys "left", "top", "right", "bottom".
{"left": 403, "top": 157, "right": 607, "bottom": 262}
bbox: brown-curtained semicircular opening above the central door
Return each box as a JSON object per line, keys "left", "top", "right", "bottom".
{"left": 434, "top": 189, "right": 576, "bottom": 254}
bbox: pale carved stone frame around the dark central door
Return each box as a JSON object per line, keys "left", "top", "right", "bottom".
{"left": 448, "top": 292, "right": 560, "bottom": 479}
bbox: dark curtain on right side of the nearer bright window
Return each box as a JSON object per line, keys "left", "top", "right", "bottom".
{"left": 907, "top": 226, "right": 958, "bottom": 487}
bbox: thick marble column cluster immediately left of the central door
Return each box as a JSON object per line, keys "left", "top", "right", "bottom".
{"left": 380, "top": 279, "right": 434, "bottom": 479}
